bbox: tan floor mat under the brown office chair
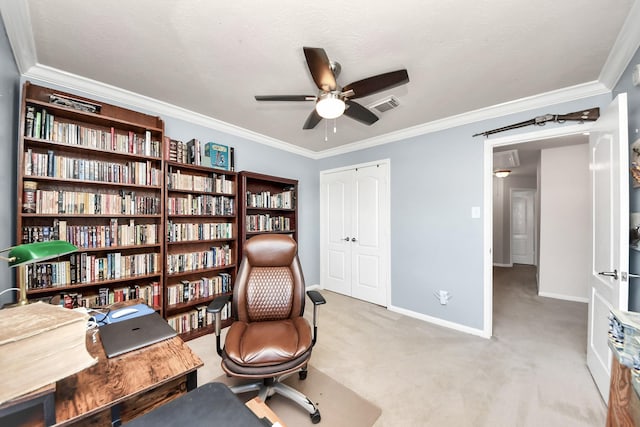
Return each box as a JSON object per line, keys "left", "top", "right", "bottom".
{"left": 214, "top": 366, "right": 382, "bottom": 427}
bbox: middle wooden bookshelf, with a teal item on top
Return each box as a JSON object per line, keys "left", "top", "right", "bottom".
{"left": 164, "top": 161, "right": 238, "bottom": 340}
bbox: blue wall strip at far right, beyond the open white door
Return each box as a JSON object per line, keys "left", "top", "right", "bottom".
{"left": 613, "top": 45, "right": 640, "bottom": 311}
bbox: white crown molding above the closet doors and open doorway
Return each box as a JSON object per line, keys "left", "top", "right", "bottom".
{"left": 317, "top": 81, "right": 611, "bottom": 159}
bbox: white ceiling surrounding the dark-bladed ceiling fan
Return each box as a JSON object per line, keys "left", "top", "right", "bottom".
{"left": 0, "top": 0, "right": 640, "bottom": 154}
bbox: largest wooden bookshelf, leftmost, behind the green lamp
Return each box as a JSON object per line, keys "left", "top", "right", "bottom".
{"left": 16, "top": 82, "right": 165, "bottom": 314}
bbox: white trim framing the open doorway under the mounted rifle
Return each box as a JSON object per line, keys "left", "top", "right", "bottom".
{"left": 482, "top": 122, "right": 593, "bottom": 338}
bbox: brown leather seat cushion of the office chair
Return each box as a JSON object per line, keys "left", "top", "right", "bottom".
{"left": 224, "top": 317, "right": 312, "bottom": 367}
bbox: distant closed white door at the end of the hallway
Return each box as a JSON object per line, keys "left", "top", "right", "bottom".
{"left": 511, "top": 190, "right": 535, "bottom": 265}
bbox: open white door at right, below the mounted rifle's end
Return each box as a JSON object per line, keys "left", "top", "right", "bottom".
{"left": 587, "top": 94, "right": 629, "bottom": 401}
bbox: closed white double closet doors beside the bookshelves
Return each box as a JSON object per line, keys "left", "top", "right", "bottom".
{"left": 320, "top": 163, "right": 390, "bottom": 306}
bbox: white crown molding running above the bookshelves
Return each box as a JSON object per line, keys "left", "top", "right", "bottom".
{"left": 23, "top": 64, "right": 317, "bottom": 158}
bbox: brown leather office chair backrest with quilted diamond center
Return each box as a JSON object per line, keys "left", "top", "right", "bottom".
{"left": 232, "top": 234, "right": 305, "bottom": 322}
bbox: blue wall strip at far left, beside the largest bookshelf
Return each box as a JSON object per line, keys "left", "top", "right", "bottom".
{"left": 0, "top": 19, "right": 20, "bottom": 306}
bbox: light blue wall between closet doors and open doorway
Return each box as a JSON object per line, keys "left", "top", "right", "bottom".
{"left": 318, "top": 94, "right": 611, "bottom": 330}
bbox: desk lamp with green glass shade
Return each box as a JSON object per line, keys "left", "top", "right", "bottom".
{"left": 0, "top": 240, "right": 78, "bottom": 305}
